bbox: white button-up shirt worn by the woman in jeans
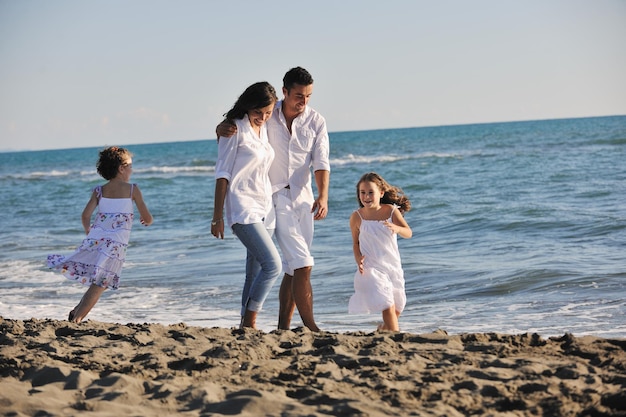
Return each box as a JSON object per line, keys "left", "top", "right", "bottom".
{"left": 215, "top": 115, "right": 274, "bottom": 226}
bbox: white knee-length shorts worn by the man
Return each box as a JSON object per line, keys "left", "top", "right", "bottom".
{"left": 272, "top": 188, "right": 314, "bottom": 276}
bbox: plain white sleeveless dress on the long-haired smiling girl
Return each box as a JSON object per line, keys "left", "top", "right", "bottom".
{"left": 348, "top": 206, "right": 406, "bottom": 314}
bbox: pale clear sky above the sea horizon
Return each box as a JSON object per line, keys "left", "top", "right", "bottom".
{"left": 0, "top": 0, "right": 626, "bottom": 150}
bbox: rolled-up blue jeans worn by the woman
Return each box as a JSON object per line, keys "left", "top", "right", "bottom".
{"left": 233, "top": 223, "right": 281, "bottom": 316}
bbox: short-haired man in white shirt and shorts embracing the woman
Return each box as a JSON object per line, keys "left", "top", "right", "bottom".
{"left": 216, "top": 67, "right": 330, "bottom": 331}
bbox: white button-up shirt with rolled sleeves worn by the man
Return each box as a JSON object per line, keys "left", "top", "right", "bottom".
{"left": 267, "top": 101, "right": 330, "bottom": 203}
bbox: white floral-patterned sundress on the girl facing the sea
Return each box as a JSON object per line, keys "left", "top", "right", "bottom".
{"left": 47, "top": 184, "right": 134, "bottom": 290}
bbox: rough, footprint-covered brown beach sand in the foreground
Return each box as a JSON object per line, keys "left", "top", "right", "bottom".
{"left": 0, "top": 318, "right": 626, "bottom": 417}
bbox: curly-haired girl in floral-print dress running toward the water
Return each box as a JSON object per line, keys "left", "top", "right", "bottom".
{"left": 48, "top": 146, "right": 152, "bottom": 323}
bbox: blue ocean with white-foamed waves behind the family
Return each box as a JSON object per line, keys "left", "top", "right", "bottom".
{"left": 0, "top": 116, "right": 626, "bottom": 337}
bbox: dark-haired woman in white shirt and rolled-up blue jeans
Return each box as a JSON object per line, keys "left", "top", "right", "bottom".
{"left": 211, "top": 82, "right": 281, "bottom": 328}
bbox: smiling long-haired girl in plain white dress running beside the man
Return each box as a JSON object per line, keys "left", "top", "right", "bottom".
{"left": 348, "top": 172, "right": 413, "bottom": 332}
